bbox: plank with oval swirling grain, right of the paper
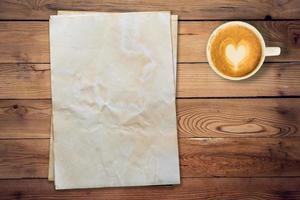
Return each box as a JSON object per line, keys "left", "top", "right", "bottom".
{"left": 177, "top": 98, "right": 300, "bottom": 138}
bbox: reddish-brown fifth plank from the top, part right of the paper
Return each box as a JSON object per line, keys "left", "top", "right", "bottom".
{"left": 179, "top": 138, "right": 300, "bottom": 177}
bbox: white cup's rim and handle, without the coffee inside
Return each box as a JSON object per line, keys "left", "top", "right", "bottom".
{"left": 206, "top": 21, "right": 281, "bottom": 81}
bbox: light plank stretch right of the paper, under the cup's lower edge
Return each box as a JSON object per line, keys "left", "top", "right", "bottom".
{"left": 177, "top": 63, "right": 300, "bottom": 97}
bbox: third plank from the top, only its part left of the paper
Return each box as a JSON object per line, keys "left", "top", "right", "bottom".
{"left": 0, "top": 64, "right": 51, "bottom": 99}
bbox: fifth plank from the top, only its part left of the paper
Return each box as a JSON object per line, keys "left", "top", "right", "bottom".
{"left": 0, "top": 139, "right": 49, "bottom": 179}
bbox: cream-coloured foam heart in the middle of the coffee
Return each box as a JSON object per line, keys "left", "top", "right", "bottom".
{"left": 226, "top": 44, "right": 247, "bottom": 69}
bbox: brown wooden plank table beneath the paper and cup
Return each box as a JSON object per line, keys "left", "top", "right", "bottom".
{"left": 0, "top": 0, "right": 300, "bottom": 200}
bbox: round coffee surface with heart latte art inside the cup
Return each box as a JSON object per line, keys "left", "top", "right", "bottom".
{"left": 209, "top": 24, "right": 262, "bottom": 77}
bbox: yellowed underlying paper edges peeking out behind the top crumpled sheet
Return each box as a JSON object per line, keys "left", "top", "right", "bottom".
{"left": 48, "top": 10, "right": 178, "bottom": 181}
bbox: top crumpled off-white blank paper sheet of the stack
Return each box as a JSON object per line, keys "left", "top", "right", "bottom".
{"left": 50, "top": 12, "right": 180, "bottom": 189}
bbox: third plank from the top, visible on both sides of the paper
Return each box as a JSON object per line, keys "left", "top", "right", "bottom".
{"left": 0, "top": 63, "right": 300, "bottom": 99}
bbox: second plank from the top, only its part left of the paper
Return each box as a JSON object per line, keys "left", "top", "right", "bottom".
{"left": 0, "top": 21, "right": 49, "bottom": 63}
